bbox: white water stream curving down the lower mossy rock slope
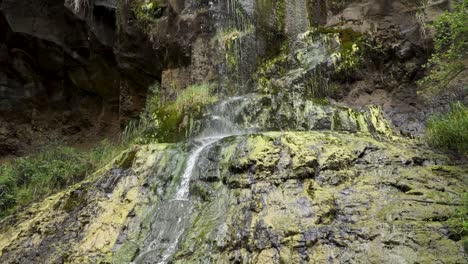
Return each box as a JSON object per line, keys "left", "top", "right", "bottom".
{"left": 133, "top": 96, "right": 253, "bottom": 264}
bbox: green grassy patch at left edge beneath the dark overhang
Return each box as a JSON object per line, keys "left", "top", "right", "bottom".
{"left": 0, "top": 141, "right": 118, "bottom": 217}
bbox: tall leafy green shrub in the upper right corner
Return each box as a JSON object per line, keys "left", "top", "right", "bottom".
{"left": 419, "top": 0, "right": 468, "bottom": 98}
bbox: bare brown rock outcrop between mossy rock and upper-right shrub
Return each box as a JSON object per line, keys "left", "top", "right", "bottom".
{"left": 322, "top": 0, "right": 467, "bottom": 136}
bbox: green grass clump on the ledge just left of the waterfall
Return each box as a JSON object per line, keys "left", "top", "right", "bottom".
{"left": 123, "top": 83, "right": 218, "bottom": 144}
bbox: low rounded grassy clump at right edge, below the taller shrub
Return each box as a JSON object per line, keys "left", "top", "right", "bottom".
{"left": 426, "top": 103, "right": 468, "bottom": 155}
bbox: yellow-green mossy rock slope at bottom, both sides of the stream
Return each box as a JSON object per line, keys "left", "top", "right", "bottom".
{"left": 0, "top": 127, "right": 467, "bottom": 263}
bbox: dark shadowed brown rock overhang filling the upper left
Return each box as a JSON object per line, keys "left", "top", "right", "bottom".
{"left": 0, "top": 0, "right": 207, "bottom": 156}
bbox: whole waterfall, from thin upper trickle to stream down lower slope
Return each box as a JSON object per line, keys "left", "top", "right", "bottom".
{"left": 133, "top": 0, "right": 253, "bottom": 264}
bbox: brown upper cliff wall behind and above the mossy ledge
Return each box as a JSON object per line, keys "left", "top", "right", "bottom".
{"left": 0, "top": 0, "right": 458, "bottom": 156}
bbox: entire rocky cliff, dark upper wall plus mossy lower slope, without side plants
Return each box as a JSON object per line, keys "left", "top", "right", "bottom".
{"left": 0, "top": 0, "right": 468, "bottom": 264}
